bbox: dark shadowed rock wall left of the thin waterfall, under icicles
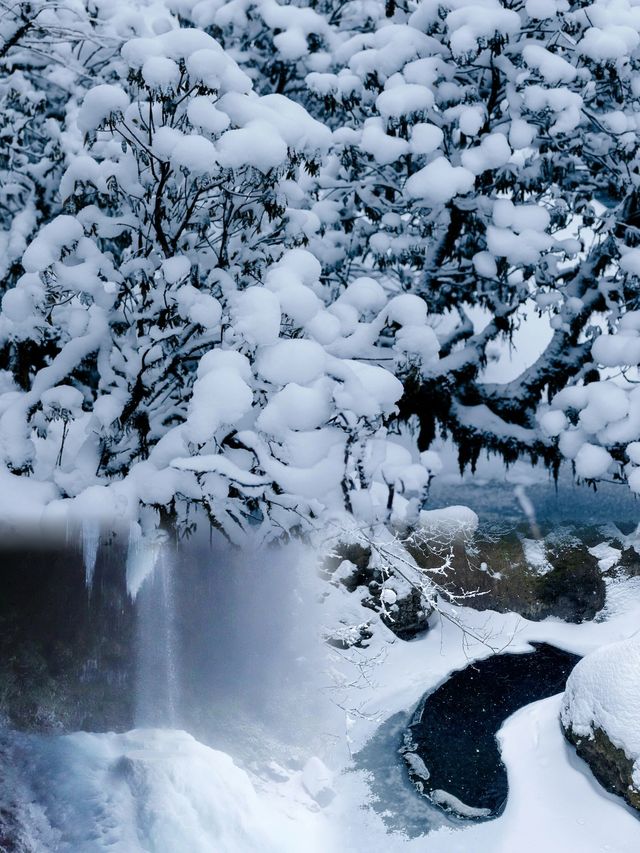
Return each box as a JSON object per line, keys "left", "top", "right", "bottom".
{"left": 0, "top": 541, "right": 134, "bottom": 731}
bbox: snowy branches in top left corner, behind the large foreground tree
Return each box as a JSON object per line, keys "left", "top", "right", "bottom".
{"left": 0, "top": 0, "right": 175, "bottom": 292}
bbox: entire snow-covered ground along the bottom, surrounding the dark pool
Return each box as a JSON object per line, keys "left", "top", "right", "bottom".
{"left": 5, "top": 540, "right": 640, "bottom": 853}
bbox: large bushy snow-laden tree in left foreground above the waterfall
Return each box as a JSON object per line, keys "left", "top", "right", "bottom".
{"left": 0, "top": 29, "right": 444, "bottom": 537}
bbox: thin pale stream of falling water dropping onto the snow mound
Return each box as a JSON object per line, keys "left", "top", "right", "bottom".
{"left": 135, "top": 537, "right": 180, "bottom": 728}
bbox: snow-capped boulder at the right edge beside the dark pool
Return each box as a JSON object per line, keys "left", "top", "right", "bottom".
{"left": 561, "top": 635, "right": 640, "bottom": 810}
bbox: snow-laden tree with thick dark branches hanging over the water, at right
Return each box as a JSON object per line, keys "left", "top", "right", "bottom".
{"left": 298, "top": 2, "right": 638, "bottom": 477}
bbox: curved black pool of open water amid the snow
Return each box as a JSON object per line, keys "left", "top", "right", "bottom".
{"left": 401, "top": 644, "right": 579, "bottom": 818}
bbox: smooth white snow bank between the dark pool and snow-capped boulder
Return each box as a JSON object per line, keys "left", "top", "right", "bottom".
{"left": 332, "top": 696, "right": 640, "bottom": 853}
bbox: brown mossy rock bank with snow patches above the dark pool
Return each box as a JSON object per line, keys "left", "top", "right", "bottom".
{"left": 412, "top": 530, "right": 605, "bottom": 623}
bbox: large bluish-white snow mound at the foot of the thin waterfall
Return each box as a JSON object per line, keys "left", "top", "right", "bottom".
{"left": 11, "top": 729, "right": 321, "bottom": 853}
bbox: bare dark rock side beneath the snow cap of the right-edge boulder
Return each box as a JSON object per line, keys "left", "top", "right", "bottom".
{"left": 562, "top": 725, "right": 640, "bottom": 811}
